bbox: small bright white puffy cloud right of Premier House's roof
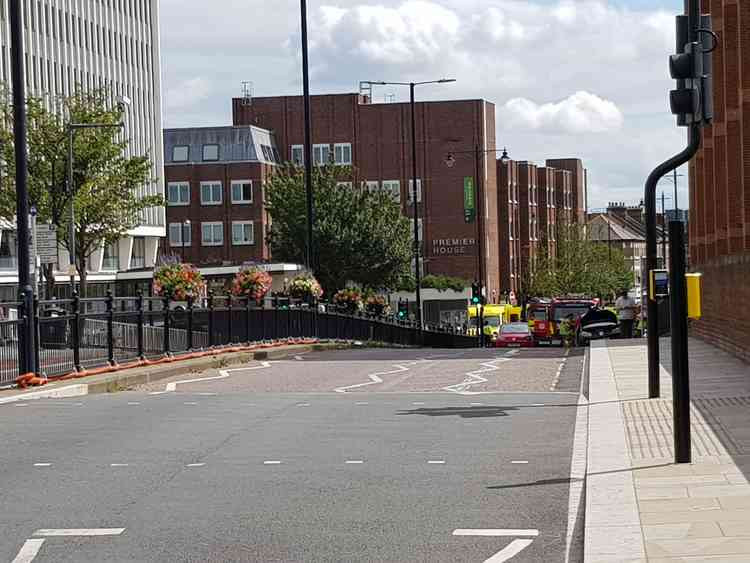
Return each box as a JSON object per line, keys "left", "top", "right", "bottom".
{"left": 499, "top": 92, "right": 623, "bottom": 134}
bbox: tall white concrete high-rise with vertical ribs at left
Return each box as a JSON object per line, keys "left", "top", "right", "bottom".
{"left": 0, "top": 0, "right": 165, "bottom": 297}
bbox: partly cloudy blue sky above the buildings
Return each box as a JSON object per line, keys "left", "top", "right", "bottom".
{"left": 160, "top": 0, "right": 687, "bottom": 209}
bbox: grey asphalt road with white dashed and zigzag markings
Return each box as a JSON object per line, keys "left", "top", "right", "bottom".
{"left": 0, "top": 349, "right": 583, "bottom": 563}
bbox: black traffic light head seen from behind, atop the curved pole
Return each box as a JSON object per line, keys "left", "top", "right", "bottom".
{"left": 669, "top": 15, "right": 714, "bottom": 126}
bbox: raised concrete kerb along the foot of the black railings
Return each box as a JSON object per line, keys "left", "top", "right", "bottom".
{"left": 0, "top": 341, "right": 367, "bottom": 405}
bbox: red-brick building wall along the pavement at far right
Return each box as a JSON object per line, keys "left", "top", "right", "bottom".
{"left": 689, "top": 0, "right": 750, "bottom": 361}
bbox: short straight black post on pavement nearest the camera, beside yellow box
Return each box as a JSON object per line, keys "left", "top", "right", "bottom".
{"left": 669, "top": 221, "right": 691, "bottom": 463}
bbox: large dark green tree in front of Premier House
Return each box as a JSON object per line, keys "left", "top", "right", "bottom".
{"left": 265, "top": 164, "right": 412, "bottom": 296}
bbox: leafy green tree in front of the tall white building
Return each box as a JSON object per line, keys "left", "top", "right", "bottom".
{"left": 0, "top": 90, "right": 164, "bottom": 296}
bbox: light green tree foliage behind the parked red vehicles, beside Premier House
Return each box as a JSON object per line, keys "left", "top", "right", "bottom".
{"left": 523, "top": 226, "right": 633, "bottom": 297}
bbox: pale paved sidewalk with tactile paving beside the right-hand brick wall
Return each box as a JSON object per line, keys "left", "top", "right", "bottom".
{"left": 584, "top": 339, "right": 750, "bottom": 563}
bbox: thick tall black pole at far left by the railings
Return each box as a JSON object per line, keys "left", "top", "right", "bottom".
{"left": 9, "top": 0, "right": 36, "bottom": 375}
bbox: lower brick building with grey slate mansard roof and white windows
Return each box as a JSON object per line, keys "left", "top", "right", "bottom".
{"left": 163, "top": 127, "right": 279, "bottom": 266}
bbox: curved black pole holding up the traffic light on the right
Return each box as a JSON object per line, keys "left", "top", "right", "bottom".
{"left": 644, "top": 125, "right": 701, "bottom": 399}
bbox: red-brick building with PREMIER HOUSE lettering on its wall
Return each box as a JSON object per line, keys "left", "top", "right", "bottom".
{"left": 232, "top": 94, "right": 501, "bottom": 299}
